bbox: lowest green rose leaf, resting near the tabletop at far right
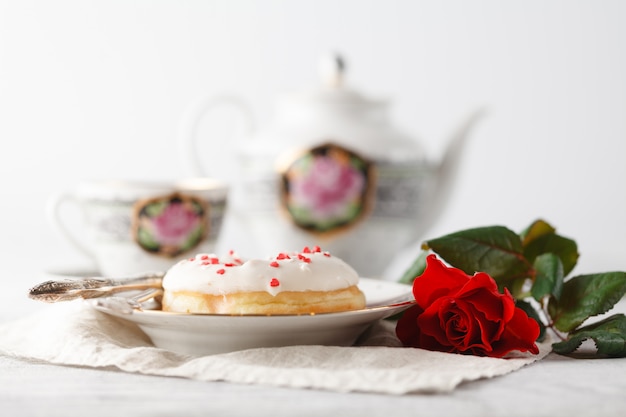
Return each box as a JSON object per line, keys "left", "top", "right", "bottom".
{"left": 552, "top": 314, "right": 626, "bottom": 358}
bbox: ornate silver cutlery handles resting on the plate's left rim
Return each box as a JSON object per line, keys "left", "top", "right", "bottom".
{"left": 28, "top": 272, "right": 163, "bottom": 303}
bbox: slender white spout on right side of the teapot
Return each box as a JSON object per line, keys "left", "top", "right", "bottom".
{"left": 423, "top": 108, "right": 486, "bottom": 227}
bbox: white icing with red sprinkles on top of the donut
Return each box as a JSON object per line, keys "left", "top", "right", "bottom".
{"left": 163, "top": 247, "right": 359, "bottom": 295}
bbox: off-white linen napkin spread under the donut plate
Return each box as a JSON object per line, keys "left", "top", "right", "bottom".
{"left": 0, "top": 301, "right": 550, "bottom": 394}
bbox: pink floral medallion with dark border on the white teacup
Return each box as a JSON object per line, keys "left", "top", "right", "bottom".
{"left": 133, "top": 193, "right": 209, "bottom": 257}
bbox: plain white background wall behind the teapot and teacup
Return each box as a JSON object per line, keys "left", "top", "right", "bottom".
{"left": 0, "top": 0, "right": 626, "bottom": 282}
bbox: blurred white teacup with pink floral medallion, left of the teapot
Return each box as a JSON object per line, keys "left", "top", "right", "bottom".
{"left": 48, "top": 178, "right": 228, "bottom": 277}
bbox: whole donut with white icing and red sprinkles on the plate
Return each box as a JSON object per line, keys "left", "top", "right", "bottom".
{"left": 162, "top": 246, "right": 365, "bottom": 315}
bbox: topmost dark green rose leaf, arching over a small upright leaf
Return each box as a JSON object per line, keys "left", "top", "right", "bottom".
{"left": 524, "top": 230, "right": 579, "bottom": 276}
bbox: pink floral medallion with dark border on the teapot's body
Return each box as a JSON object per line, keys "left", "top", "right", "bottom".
{"left": 281, "top": 144, "right": 375, "bottom": 235}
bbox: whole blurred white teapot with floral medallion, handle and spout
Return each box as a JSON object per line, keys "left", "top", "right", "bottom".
{"left": 181, "top": 57, "right": 479, "bottom": 277}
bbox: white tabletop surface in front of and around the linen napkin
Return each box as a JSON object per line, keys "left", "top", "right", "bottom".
{"left": 0, "top": 250, "right": 626, "bottom": 417}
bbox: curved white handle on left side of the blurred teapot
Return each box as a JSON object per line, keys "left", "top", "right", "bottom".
{"left": 179, "top": 94, "right": 254, "bottom": 176}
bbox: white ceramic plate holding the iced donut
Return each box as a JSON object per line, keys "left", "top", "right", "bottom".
{"left": 92, "top": 278, "right": 413, "bottom": 355}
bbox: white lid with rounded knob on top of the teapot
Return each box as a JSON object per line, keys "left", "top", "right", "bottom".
{"left": 281, "top": 54, "right": 387, "bottom": 107}
